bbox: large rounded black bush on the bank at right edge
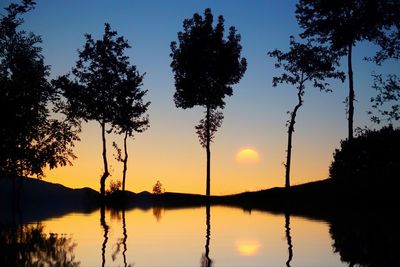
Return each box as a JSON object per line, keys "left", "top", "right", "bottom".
{"left": 329, "top": 125, "right": 400, "bottom": 186}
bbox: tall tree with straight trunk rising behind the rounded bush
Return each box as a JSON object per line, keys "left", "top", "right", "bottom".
{"left": 296, "top": 0, "right": 398, "bottom": 139}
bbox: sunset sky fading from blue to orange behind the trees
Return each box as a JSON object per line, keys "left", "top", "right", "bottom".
{"left": 0, "top": 0, "right": 400, "bottom": 195}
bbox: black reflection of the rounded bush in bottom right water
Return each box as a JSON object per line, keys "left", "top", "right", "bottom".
{"left": 329, "top": 213, "right": 400, "bottom": 267}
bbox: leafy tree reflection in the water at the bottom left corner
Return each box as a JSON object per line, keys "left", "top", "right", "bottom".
{"left": 0, "top": 223, "right": 80, "bottom": 266}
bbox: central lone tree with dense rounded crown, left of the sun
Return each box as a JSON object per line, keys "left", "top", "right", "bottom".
{"left": 170, "top": 8, "right": 247, "bottom": 196}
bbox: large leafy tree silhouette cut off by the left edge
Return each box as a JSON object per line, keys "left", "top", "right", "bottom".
{"left": 0, "top": 0, "right": 79, "bottom": 181}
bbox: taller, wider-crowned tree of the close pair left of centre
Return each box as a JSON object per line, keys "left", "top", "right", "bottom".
{"left": 53, "top": 23, "right": 138, "bottom": 196}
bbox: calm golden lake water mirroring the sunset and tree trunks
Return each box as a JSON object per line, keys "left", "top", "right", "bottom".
{"left": 0, "top": 206, "right": 348, "bottom": 267}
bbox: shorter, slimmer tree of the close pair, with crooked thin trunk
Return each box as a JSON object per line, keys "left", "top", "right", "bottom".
{"left": 112, "top": 65, "right": 150, "bottom": 191}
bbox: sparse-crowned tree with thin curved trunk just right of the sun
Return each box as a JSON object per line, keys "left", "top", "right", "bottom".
{"left": 268, "top": 36, "right": 344, "bottom": 188}
